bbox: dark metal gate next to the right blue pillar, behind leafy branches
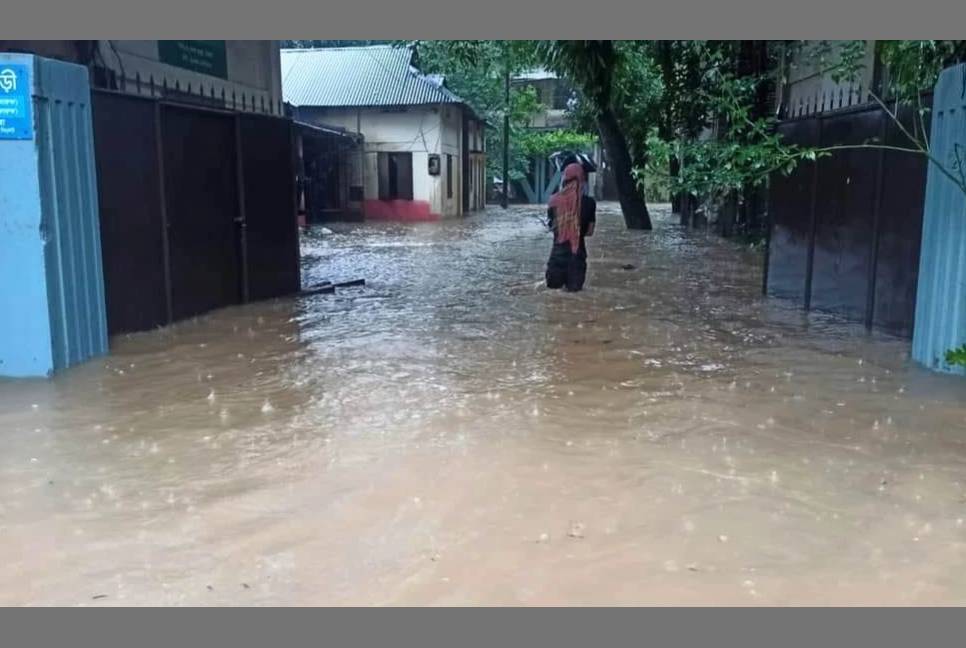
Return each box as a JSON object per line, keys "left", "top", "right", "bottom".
{"left": 765, "top": 100, "right": 926, "bottom": 337}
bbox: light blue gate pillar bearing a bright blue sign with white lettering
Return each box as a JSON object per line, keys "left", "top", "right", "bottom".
{"left": 0, "top": 54, "right": 108, "bottom": 377}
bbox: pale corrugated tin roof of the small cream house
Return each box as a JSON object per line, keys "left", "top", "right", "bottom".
{"left": 281, "top": 45, "right": 465, "bottom": 112}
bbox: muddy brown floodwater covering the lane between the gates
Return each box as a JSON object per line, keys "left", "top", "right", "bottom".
{"left": 0, "top": 207, "right": 966, "bottom": 605}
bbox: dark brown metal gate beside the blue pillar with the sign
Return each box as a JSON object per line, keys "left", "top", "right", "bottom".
{"left": 93, "top": 91, "right": 299, "bottom": 334}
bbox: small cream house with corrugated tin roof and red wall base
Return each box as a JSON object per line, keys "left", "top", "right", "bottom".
{"left": 281, "top": 45, "right": 486, "bottom": 221}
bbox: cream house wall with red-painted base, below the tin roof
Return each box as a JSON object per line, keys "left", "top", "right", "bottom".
{"left": 299, "top": 106, "right": 463, "bottom": 221}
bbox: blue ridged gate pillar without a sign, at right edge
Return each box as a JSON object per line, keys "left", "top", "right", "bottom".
{"left": 912, "top": 64, "right": 966, "bottom": 375}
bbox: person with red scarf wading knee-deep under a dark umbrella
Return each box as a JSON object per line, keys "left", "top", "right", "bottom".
{"left": 547, "top": 162, "right": 597, "bottom": 292}
